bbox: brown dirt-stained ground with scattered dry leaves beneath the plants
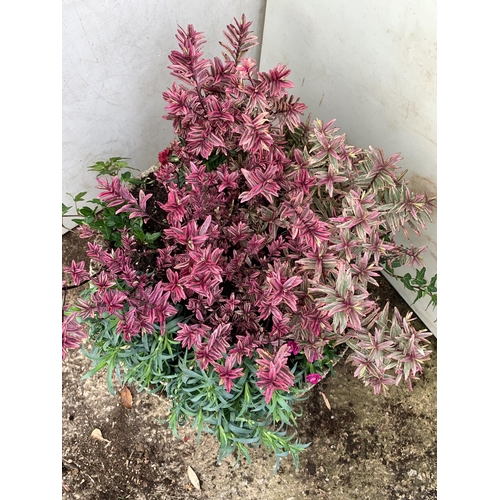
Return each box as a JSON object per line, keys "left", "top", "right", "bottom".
{"left": 62, "top": 229, "right": 437, "bottom": 500}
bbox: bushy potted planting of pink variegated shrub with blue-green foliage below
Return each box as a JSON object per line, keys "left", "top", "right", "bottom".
{"left": 63, "top": 16, "right": 436, "bottom": 470}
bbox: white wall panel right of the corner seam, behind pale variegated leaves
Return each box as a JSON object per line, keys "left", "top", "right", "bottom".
{"left": 260, "top": 0, "right": 437, "bottom": 333}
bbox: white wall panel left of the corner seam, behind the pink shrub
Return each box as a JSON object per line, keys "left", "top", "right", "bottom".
{"left": 62, "top": 0, "right": 265, "bottom": 232}
